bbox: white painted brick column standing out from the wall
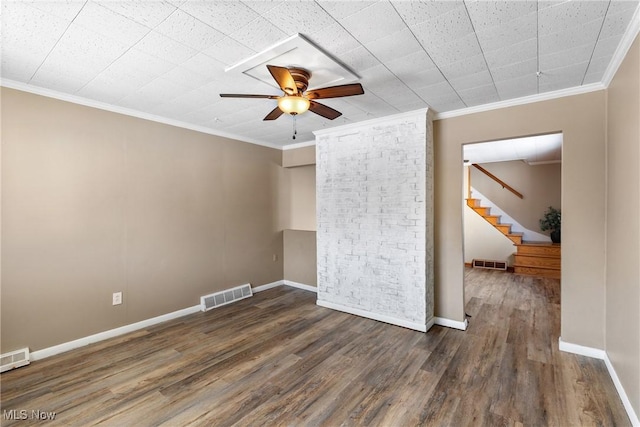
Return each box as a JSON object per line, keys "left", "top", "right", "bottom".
{"left": 316, "top": 110, "right": 433, "bottom": 331}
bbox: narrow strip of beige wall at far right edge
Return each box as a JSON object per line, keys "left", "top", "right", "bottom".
{"left": 606, "top": 37, "right": 640, "bottom": 416}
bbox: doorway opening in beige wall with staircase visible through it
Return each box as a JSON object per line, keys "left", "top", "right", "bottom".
{"left": 462, "top": 133, "right": 562, "bottom": 344}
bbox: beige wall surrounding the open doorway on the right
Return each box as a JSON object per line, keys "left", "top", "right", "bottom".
{"left": 434, "top": 91, "right": 606, "bottom": 348}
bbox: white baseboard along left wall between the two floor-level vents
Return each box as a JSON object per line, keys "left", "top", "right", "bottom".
{"left": 31, "top": 305, "right": 200, "bottom": 360}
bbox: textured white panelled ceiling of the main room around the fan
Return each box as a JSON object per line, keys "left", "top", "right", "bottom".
{"left": 1, "top": 0, "right": 639, "bottom": 146}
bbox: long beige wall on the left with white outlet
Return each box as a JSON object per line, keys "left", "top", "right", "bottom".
{"left": 1, "top": 88, "right": 283, "bottom": 352}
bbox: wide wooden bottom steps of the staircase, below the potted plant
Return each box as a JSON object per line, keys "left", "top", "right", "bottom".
{"left": 513, "top": 242, "right": 561, "bottom": 279}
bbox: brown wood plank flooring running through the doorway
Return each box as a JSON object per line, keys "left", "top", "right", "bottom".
{"left": 0, "top": 268, "right": 630, "bottom": 426}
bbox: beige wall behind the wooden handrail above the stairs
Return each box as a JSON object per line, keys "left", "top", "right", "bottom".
{"left": 471, "top": 161, "right": 562, "bottom": 234}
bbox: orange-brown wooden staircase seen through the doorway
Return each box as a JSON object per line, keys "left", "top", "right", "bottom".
{"left": 466, "top": 199, "right": 561, "bottom": 279}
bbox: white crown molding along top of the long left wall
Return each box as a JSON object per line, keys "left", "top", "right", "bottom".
{"left": 0, "top": 79, "right": 282, "bottom": 150}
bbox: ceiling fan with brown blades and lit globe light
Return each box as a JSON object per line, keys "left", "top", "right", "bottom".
{"left": 220, "top": 65, "right": 364, "bottom": 120}
